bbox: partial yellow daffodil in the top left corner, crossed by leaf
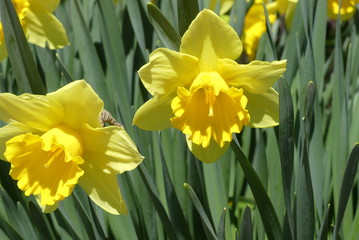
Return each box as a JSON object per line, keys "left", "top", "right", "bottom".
{"left": 0, "top": 0, "right": 68, "bottom": 61}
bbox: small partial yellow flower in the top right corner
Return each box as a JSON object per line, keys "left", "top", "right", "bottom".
{"left": 327, "top": 0, "right": 359, "bottom": 21}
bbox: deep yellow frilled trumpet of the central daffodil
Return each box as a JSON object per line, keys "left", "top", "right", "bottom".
{"left": 171, "top": 73, "right": 250, "bottom": 148}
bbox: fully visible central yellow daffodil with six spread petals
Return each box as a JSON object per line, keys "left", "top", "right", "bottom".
{"left": 133, "top": 10, "right": 286, "bottom": 163}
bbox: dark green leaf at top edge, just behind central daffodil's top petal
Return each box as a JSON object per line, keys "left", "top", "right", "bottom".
{"left": 177, "top": 0, "right": 199, "bottom": 36}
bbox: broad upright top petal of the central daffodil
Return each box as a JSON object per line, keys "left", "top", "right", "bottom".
{"left": 180, "top": 9, "right": 242, "bottom": 72}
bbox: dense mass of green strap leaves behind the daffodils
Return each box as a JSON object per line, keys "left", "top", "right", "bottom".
{"left": 0, "top": 0, "right": 359, "bottom": 240}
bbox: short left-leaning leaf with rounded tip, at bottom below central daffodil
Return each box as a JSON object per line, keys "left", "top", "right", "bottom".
{"left": 183, "top": 183, "right": 217, "bottom": 239}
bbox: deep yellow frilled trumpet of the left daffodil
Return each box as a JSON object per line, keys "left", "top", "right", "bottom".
{"left": 4, "top": 126, "right": 84, "bottom": 206}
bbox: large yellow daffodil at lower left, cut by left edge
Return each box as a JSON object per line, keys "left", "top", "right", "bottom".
{"left": 0, "top": 80, "right": 143, "bottom": 214}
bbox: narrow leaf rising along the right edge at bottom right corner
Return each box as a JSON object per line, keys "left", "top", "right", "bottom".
{"left": 333, "top": 143, "right": 359, "bottom": 240}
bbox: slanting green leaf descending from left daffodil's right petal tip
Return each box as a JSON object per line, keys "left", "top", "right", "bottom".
{"left": 137, "top": 164, "right": 177, "bottom": 239}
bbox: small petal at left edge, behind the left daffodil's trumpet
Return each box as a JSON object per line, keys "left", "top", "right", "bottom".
{"left": 0, "top": 122, "right": 38, "bottom": 160}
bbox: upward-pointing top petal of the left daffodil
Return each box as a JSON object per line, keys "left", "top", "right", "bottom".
{"left": 47, "top": 80, "right": 103, "bottom": 129}
